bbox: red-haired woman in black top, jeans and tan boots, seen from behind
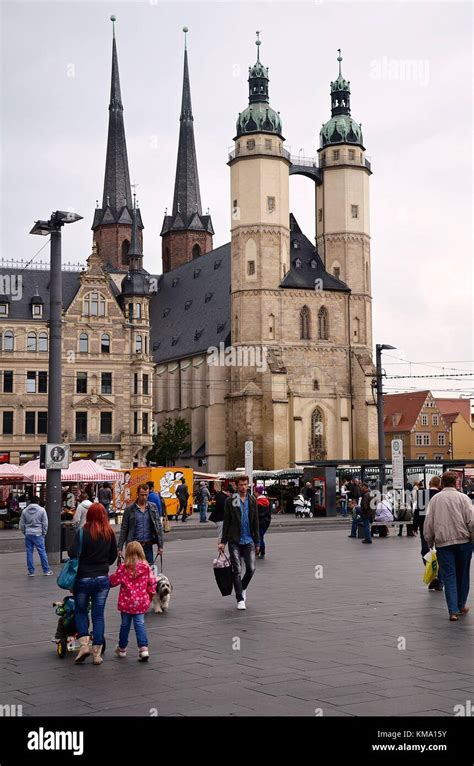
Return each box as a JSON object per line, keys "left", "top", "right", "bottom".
{"left": 68, "top": 503, "right": 117, "bottom": 665}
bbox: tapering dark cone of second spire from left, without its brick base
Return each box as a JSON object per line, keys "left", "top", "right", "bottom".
{"left": 173, "top": 27, "right": 202, "bottom": 219}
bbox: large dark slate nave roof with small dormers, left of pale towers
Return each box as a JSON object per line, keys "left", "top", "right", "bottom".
{"left": 150, "top": 242, "right": 231, "bottom": 363}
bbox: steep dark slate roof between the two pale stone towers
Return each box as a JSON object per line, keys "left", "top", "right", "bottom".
{"left": 281, "top": 213, "right": 350, "bottom": 292}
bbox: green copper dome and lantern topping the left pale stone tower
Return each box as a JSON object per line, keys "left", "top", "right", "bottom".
{"left": 236, "top": 32, "right": 282, "bottom": 138}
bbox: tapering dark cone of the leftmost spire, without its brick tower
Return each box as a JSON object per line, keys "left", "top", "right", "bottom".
{"left": 102, "top": 16, "right": 132, "bottom": 212}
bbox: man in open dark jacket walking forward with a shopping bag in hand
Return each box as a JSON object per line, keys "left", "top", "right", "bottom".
{"left": 218, "top": 476, "right": 260, "bottom": 609}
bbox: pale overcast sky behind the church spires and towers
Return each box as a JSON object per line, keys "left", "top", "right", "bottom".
{"left": 0, "top": 0, "right": 474, "bottom": 402}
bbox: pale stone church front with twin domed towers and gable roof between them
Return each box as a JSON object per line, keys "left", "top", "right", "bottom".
{"left": 226, "top": 40, "right": 376, "bottom": 469}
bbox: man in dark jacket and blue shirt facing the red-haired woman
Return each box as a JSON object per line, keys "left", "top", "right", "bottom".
{"left": 118, "top": 484, "right": 163, "bottom": 565}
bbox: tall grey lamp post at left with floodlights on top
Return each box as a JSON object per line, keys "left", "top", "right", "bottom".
{"left": 30, "top": 210, "right": 82, "bottom": 564}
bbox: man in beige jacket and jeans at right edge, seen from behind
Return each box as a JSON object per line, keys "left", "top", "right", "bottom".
{"left": 423, "top": 471, "right": 474, "bottom": 622}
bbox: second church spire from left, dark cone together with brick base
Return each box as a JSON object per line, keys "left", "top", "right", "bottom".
{"left": 161, "top": 27, "right": 214, "bottom": 272}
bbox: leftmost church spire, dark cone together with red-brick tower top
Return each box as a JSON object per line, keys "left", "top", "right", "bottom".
{"left": 92, "top": 16, "right": 143, "bottom": 269}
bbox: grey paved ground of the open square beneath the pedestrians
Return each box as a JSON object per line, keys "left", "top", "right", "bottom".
{"left": 0, "top": 528, "right": 474, "bottom": 716}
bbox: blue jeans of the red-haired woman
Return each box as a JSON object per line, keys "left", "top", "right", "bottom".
{"left": 74, "top": 575, "right": 110, "bottom": 646}
